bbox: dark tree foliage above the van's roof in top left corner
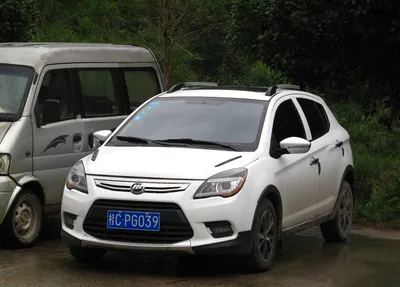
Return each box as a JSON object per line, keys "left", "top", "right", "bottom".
{"left": 0, "top": 0, "right": 39, "bottom": 42}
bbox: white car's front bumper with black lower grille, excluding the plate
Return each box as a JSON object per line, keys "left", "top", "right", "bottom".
{"left": 61, "top": 176, "right": 253, "bottom": 254}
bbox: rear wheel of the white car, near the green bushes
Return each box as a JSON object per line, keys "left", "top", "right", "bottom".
{"left": 320, "top": 181, "right": 354, "bottom": 242}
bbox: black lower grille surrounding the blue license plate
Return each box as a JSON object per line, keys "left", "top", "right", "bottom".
{"left": 83, "top": 200, "right": 193, "bottom": 244}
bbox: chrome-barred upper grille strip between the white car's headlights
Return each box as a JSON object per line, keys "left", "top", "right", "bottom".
{"left": 94, "top": 179, "right": 190, "bottom": 193}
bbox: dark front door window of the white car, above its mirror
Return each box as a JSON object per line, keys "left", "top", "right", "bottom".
{"left": 271, "top": 100, "right": 306, "bottom": 147}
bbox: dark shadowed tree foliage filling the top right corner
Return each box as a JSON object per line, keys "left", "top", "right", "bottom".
{"left": 230, "top": 0, "right": 400, "bottom": 101}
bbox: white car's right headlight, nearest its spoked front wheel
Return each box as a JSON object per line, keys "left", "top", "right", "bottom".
{"left": 194, "top": 168, "right": 247, "bottom": 198}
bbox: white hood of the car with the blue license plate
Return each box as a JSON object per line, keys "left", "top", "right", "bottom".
{"left": 84, "top": 146, "right": 257, "bottom": 180}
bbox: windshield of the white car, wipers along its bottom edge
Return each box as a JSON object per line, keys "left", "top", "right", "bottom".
{"left": 108, "top": 97, "right": 268, "bottom": 151}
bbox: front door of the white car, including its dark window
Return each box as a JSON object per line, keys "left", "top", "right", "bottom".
{"left": 271, "top": 99, "right": 318, "bottom": 229}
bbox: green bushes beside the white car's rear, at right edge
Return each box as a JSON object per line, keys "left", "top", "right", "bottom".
{"left": 332, "top": 103, "right": 400, "bottom": 227}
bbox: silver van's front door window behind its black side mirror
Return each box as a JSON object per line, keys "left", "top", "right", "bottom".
{"left": 35, "top": 70, "right": 74, "bottom": 125}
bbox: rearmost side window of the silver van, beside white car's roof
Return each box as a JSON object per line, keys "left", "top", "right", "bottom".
{"left": 124, "top": 69, "right": 161, "bottom": 111}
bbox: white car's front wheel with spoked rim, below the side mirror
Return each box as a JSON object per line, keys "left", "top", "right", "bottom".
{"left": 247, "top": 199, "right": 278, "bottom": 272}
